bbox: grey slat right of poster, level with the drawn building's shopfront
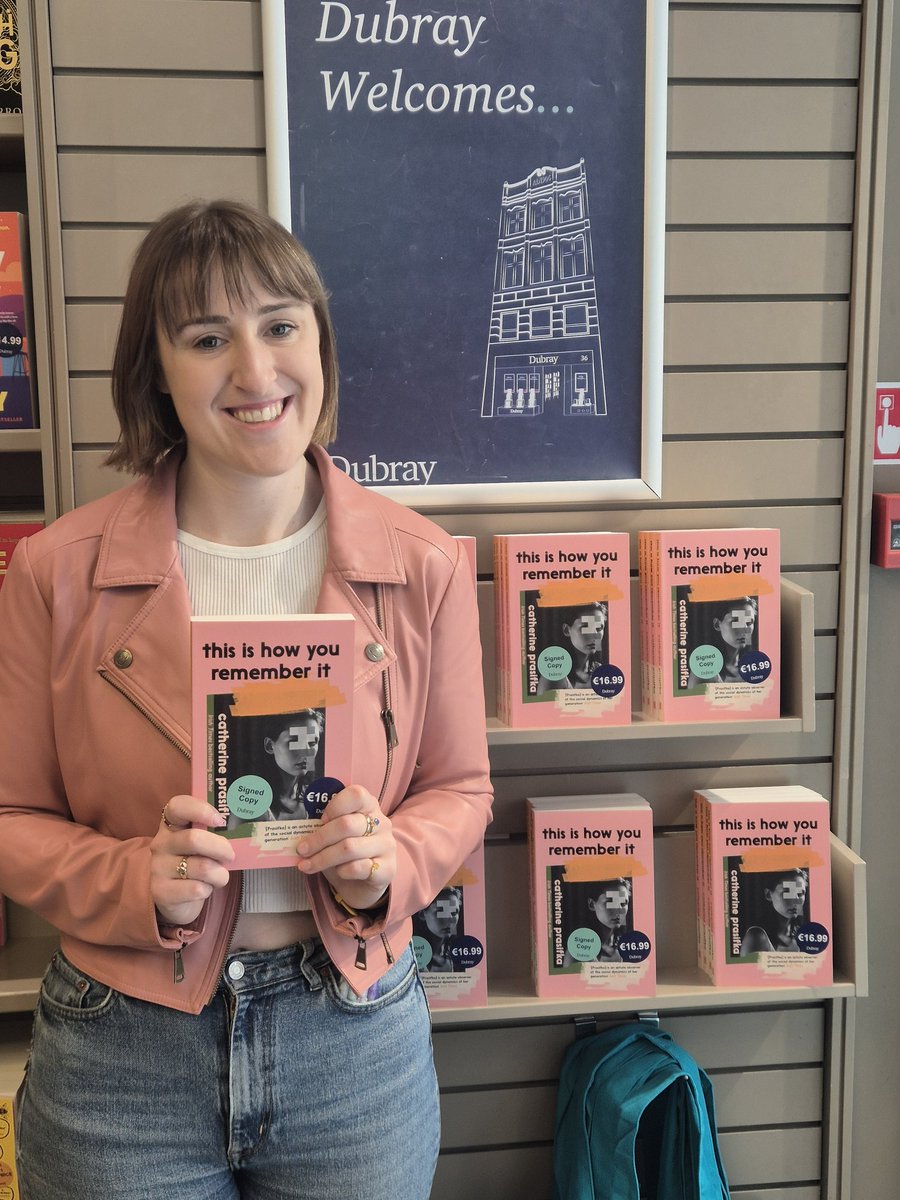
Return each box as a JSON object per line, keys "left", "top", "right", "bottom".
{"left": 662, "top": 370, "right": 847, "bottom": 437}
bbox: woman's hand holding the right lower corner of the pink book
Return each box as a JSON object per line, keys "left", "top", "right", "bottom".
{"left": 296, "top": 784, "right": 397, "bottom": 908}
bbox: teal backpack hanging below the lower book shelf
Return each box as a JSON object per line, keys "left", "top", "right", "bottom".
{"left": 553, "top": 1021, "right": 730, "bottom": 1200}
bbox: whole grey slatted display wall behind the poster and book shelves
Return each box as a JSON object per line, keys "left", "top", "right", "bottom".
{"left": 42, "top": 0, "right": 862, "bottom": 1200}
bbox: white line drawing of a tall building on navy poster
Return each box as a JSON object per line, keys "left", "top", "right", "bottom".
{"left": 481, "top": 158, "right": 606, "bottom": 418}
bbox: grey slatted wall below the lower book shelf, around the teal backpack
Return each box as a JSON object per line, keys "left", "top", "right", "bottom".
{"left": 432, "top": 1006, "right": 824, "bottom": 1200}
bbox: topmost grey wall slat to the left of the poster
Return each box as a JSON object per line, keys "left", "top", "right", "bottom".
{"left": 49, "top": 0, "right": 263, "bottom": 72}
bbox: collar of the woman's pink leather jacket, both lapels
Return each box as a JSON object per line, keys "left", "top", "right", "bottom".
{"left": 94, "top": 445, "right": 406, "bottom": 588}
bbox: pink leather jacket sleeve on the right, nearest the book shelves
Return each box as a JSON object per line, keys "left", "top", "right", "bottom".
{"left": 379, "top": 542, "right": 493, "bottom": 923}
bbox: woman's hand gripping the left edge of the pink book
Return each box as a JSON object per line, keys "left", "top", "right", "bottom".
{"left": 150, "top": 796, "right": 234, "bottom": 925}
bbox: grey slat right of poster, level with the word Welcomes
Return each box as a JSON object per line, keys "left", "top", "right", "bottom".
{"left": 668, "top": 84, "right": 857, "bottom": 154}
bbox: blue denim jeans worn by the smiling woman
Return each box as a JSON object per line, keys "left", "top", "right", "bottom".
{"left": 18, "top": 941, "right": 439, "bottom": 1200}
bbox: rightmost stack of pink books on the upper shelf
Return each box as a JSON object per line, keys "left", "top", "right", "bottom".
{"left": 638, "top": 529, "right": 781, "bottom": 721}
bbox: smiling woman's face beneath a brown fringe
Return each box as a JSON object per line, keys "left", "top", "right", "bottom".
{"left": 157, "top": 280, "right": 324, "bottom": 484}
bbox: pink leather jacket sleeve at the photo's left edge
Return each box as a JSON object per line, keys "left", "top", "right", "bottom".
{"left": 0, "top": 540, "right": 198, "bottom": 949}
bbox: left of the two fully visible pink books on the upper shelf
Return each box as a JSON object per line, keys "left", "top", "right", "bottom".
{"left": 494, "top": 533, "right": 631, "bottom": 728}
